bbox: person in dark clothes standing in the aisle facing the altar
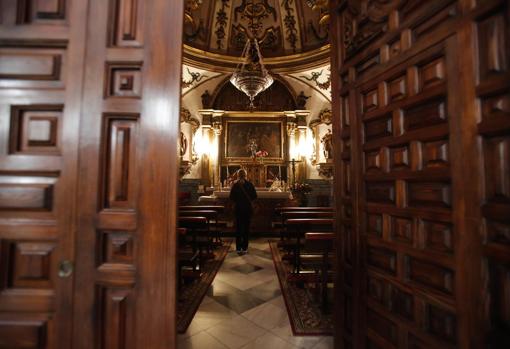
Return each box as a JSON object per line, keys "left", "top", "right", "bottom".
{"left": 230, "top": 169, "right": 257, "bottom": 254}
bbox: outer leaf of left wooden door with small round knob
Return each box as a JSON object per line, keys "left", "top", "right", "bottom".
{"left": 0, "top": 0, "right": 87, "bottom": 349}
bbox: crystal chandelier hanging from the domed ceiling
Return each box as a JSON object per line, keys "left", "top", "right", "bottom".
{"left": 230, "top": 38, "right": 274, "bottom": 108}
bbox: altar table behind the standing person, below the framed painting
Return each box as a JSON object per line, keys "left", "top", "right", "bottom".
{"left": 198, "top": 188, "right": 292, "bottom": 233}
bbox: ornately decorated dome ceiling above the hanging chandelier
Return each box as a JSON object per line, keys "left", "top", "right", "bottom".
{"left": 184, "top": 0, "right": 329, "bottom": 70}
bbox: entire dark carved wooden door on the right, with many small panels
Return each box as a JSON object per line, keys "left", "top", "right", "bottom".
{"left": 332, "top": 0, "right": 510, "bottom": 348}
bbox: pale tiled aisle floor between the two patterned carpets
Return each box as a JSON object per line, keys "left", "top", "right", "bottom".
{"left": 177, "top": 238, "right": 333, "bottom": 349}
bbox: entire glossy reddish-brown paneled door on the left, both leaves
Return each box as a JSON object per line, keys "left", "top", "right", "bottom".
{"left": 0, "top": 0, "right": 183, "bottom": 349}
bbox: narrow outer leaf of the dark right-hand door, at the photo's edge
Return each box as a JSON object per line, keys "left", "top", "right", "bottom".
{"left": 471, "top": 1, "right": 510, "bottom": 348}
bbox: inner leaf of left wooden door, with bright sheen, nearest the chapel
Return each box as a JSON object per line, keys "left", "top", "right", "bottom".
{"left": 73, "top": 0, "right": 183, "bottom": 349}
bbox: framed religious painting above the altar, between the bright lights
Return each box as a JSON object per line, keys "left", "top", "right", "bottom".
{"left": 223, "top": 115, "right": 286, "bottom": 163}
